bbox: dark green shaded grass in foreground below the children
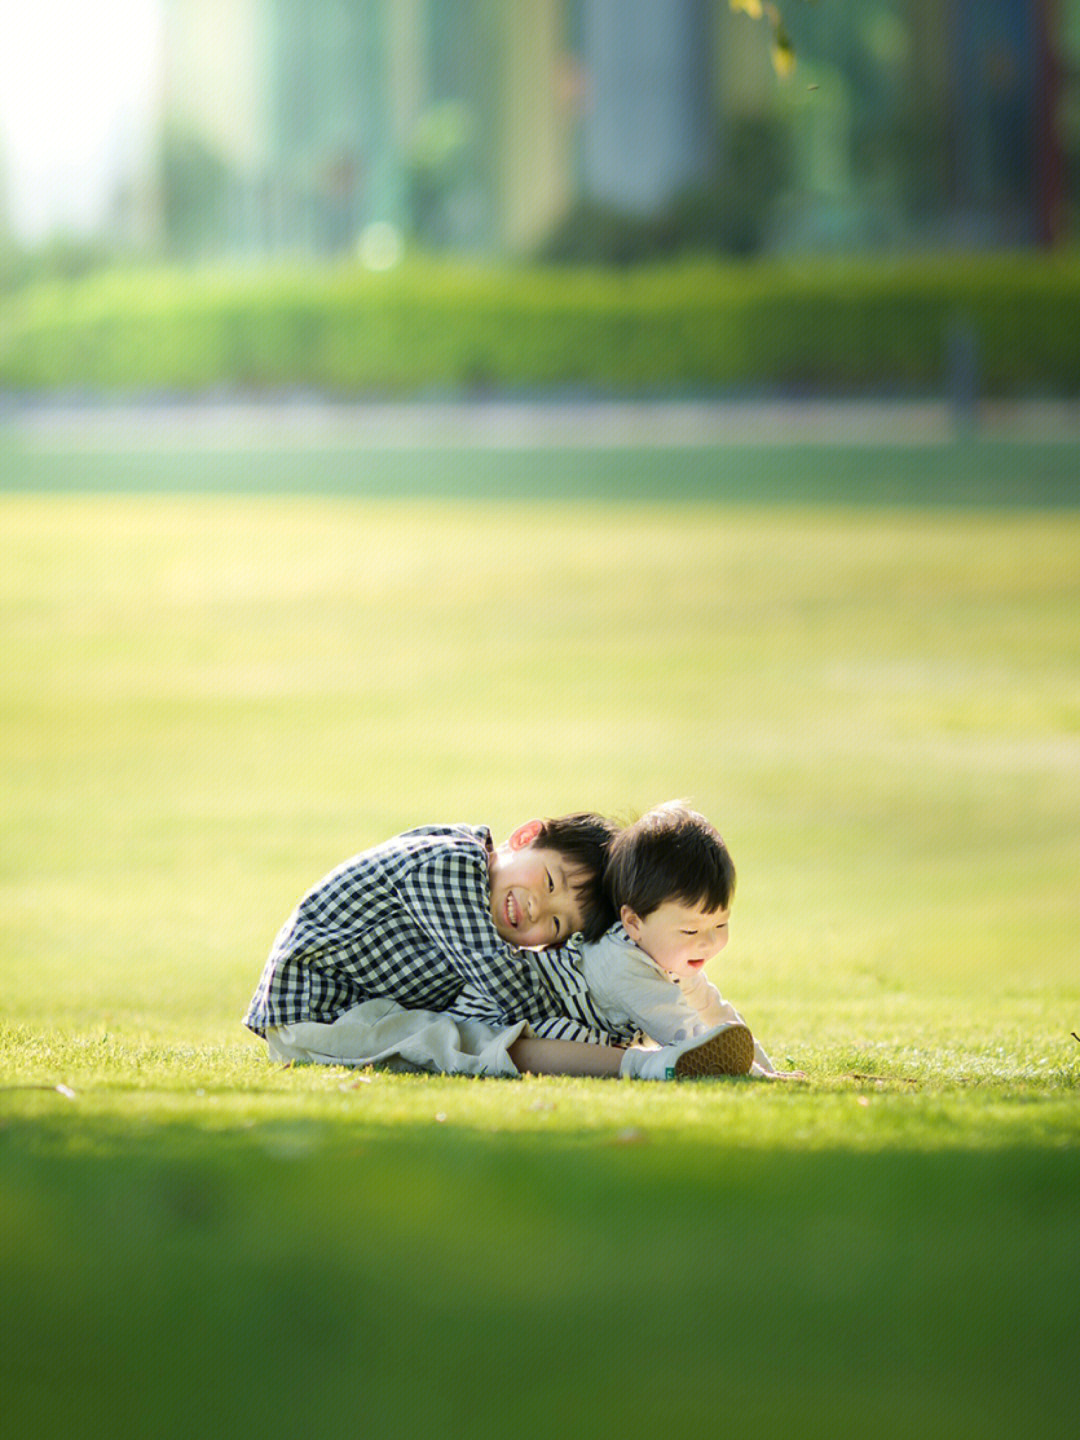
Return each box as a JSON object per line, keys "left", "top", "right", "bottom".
{"left": 0, "top": 1120, "right": 1080, "bottom": 1440}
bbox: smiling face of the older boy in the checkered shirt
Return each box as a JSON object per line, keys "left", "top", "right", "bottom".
{"left": 490, "top": 828, "right": 593, "bottom": 949}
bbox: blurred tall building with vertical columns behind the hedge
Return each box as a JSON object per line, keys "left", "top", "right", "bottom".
{"left": 157, "top": 0, "right": 1080, "bottom": 261}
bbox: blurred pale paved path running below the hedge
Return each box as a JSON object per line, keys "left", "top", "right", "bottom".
{"left": 0, "top": 399, "right": 1080, "bottom": 451}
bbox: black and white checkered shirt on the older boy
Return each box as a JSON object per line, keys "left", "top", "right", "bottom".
{"left": 243, "top": 825, "right": 611, "bottom": 1044}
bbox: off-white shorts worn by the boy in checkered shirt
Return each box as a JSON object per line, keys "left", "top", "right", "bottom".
{"left": 266, "top": 999, "right": 528, "bottom": 1076}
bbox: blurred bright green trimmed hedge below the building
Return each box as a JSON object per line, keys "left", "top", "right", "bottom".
{"left": 0, "top": 253, "right": 1080, "bottom": 396}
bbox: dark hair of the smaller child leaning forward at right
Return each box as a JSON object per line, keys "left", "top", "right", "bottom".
{"left": 605, "top": 801, "right": 734, "bottom": 920}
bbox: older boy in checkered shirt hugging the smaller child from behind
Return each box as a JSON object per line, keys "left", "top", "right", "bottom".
{"left": 245, "top": 814, "right": 749, "bottom": 1079}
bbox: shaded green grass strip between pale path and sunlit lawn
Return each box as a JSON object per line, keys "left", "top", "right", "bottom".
{"left": 0, "top": 432, "right": 1080, "bottom": 510}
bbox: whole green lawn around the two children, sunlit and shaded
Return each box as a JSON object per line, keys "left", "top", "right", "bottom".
{"left": 0, "top": 436, "right": 1080, "bottom": 1440}
